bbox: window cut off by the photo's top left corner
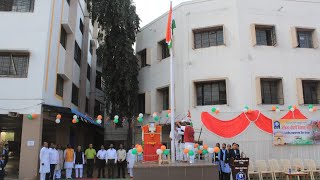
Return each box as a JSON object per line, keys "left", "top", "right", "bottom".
{"left": 0, "top": 0, "right": 34, "bottom": 12}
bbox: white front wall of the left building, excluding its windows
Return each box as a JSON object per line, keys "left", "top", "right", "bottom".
{"left": 0, "top": 1, "right": 51, "bottom": 114}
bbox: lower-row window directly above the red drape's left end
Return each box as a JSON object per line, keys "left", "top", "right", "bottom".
{"left": 196, "top": 80, "right": 227, "bottom": 106}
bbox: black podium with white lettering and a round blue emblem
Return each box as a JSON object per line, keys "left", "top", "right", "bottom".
{"left": 230, "top": 158, "right": 249, "bottom": 180}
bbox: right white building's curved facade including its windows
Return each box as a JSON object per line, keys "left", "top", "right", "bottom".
{"left": 136, "top": 0, "right": 320, "bottom": 160}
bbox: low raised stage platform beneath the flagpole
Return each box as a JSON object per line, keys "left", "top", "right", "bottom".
{"left": 133, "top": 161, "right": 219, "bottom": 180}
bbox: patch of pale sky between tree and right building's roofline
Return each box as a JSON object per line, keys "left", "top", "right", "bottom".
{"left": 133, "top": 0, "right": 189, "bottom": 27}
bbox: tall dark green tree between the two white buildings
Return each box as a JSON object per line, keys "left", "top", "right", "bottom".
{"left": 89, "top": 0, "right": 140, "bottom": 118}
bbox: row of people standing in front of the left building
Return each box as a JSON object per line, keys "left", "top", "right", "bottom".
{"left": 39, "top": 142, "right": 136, "bottom": 180}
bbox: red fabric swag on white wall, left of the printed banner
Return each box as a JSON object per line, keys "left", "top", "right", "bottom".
{"left": 201, "top": 111, "right": 272, "bottom": 138}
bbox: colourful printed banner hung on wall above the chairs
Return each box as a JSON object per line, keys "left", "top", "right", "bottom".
{"left": 273, "top": 119, "right": 320, "bottom": 146}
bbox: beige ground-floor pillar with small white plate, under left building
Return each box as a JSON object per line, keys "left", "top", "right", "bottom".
{"left": 19, "top": 115, "right": 43, "bottom": 180}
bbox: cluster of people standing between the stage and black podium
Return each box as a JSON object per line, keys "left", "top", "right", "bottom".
{"left": 212, "top": 143, "right": 241, "bottom": 180}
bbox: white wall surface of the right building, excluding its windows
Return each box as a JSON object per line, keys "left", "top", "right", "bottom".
{"left": 136, "top": 0, "right": 320, "bottom": 162}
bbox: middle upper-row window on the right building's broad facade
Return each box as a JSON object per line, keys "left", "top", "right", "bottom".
{"left": 255, "top": 25, "right": 277, "bottom": 46}
